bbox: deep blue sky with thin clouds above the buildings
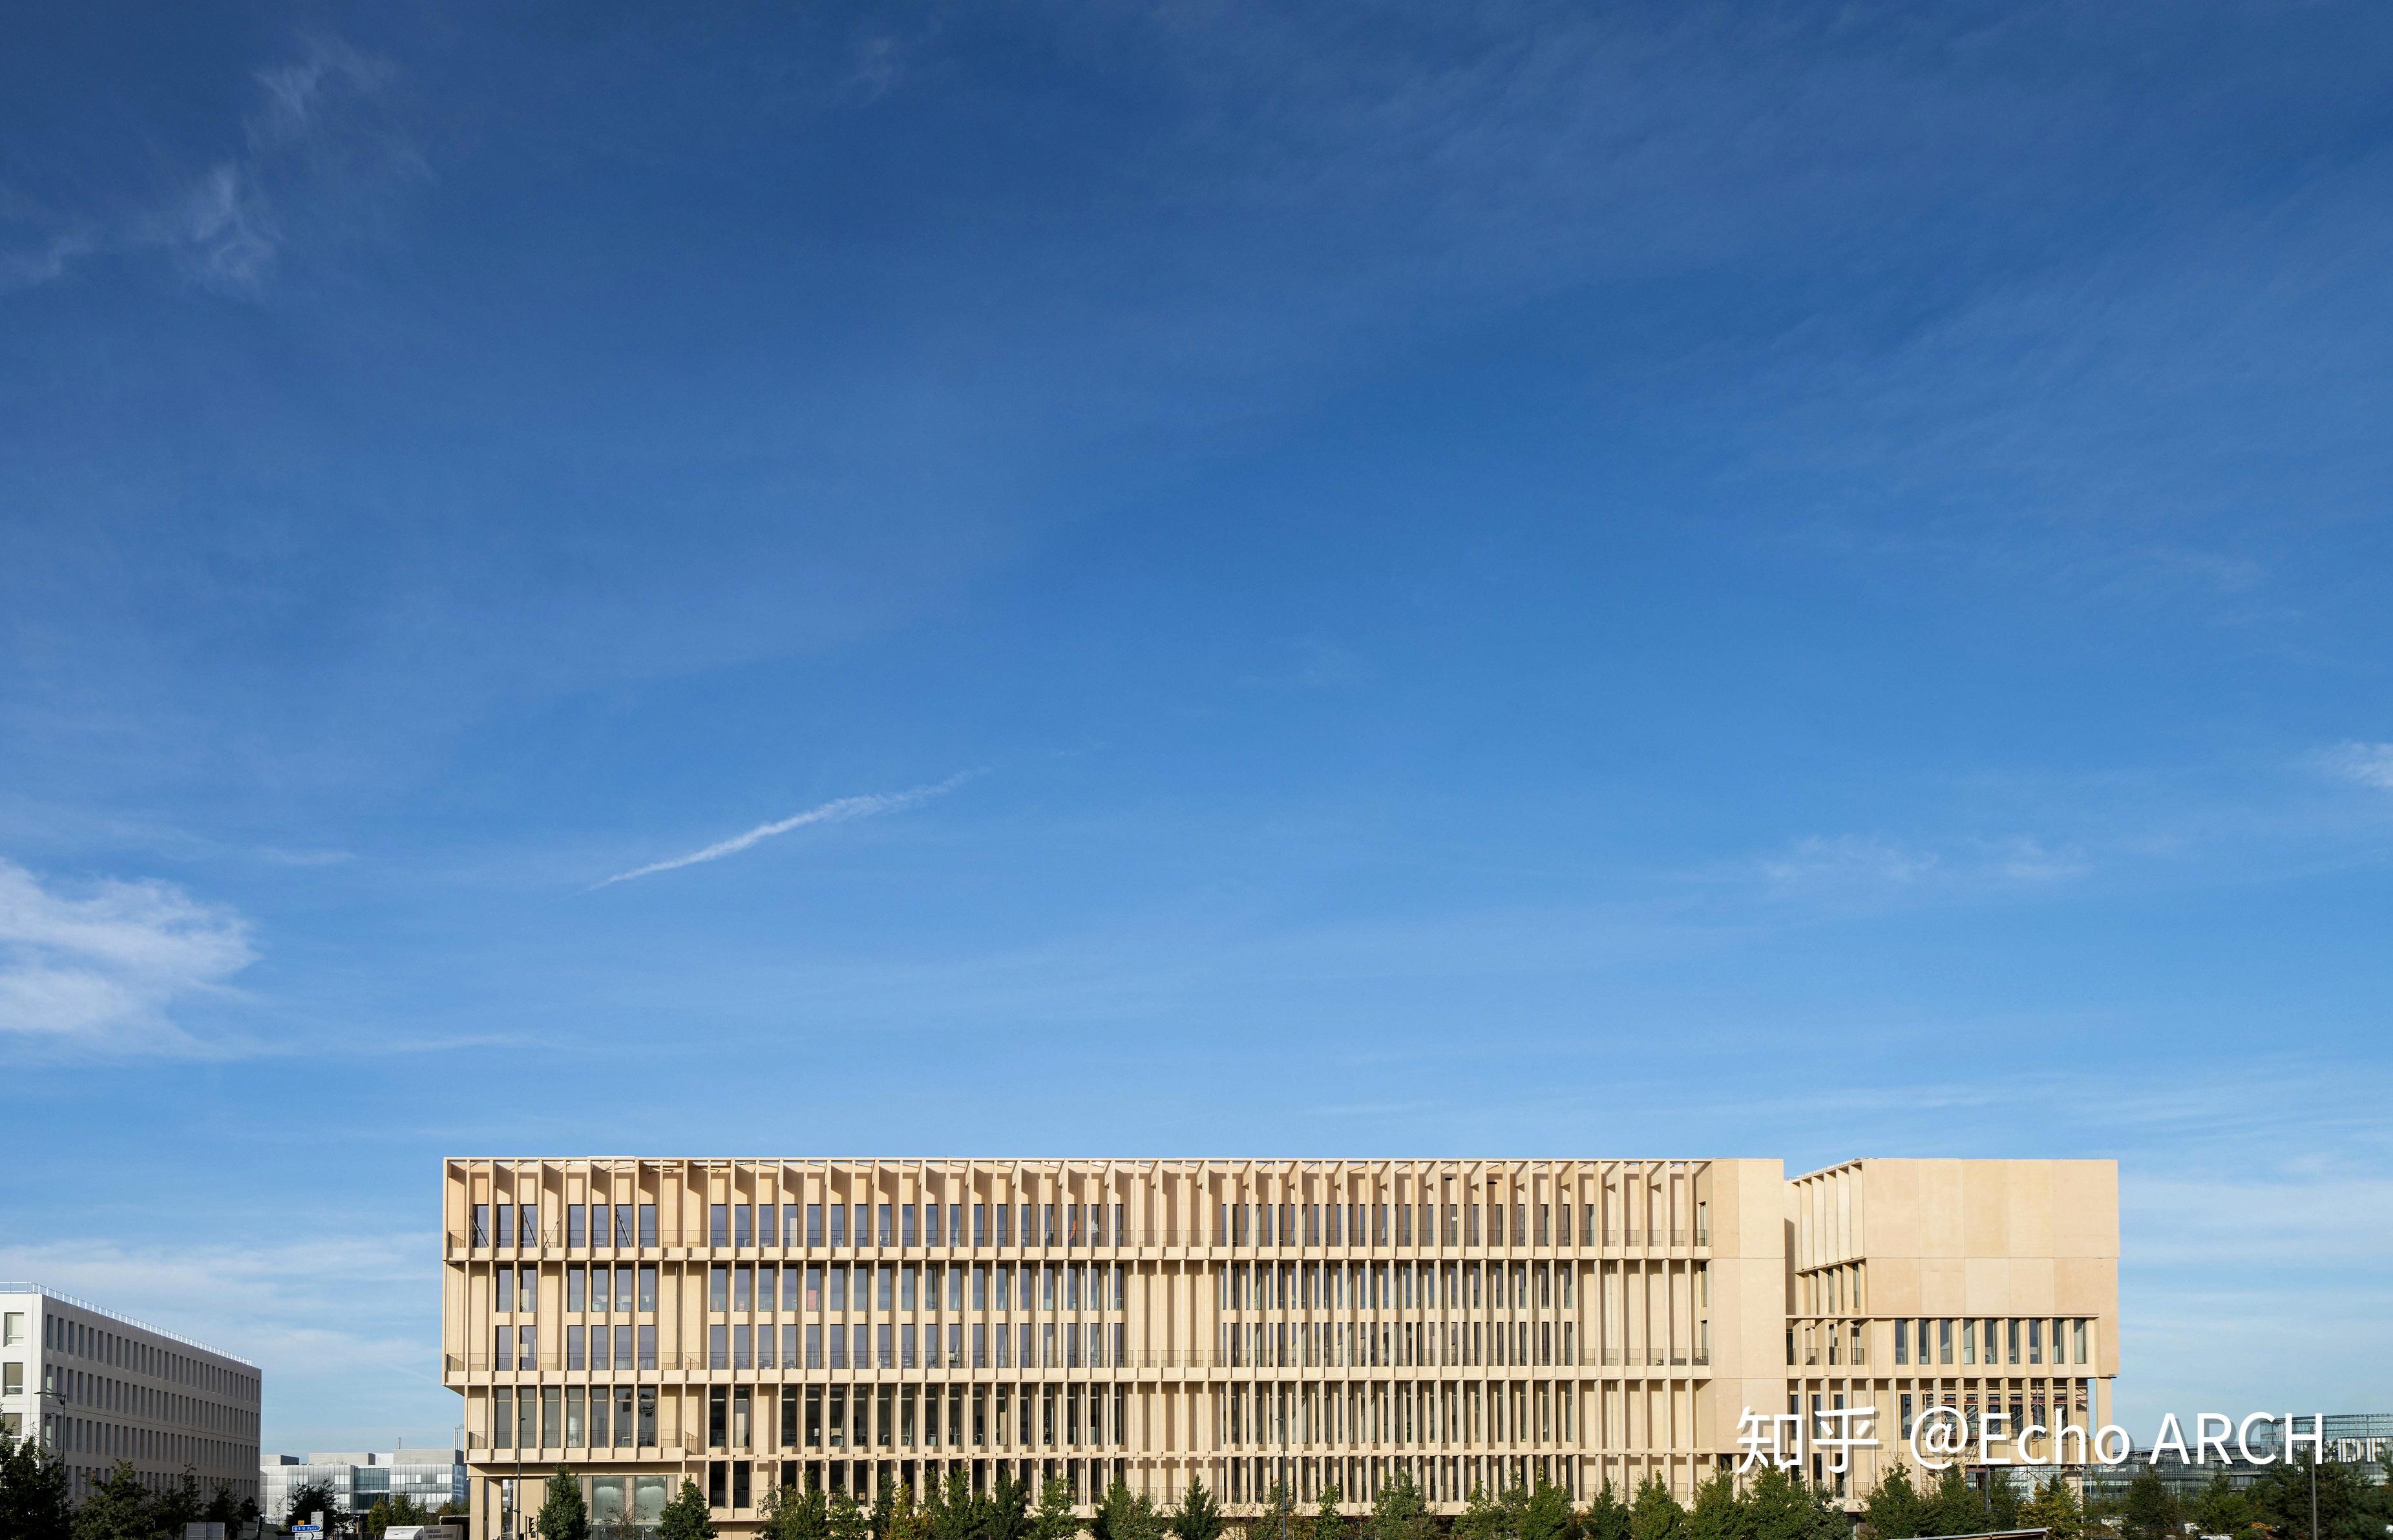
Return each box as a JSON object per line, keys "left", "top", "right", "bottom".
{"left": 0, "top": 0, "right": 2393, "bottom": 1449}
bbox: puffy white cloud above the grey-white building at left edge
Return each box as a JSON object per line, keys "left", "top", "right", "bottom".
{"left": 0, "top": 861, "right": 256, "bottom": 1048}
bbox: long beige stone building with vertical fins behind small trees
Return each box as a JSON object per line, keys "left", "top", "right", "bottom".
{"left": 443, "top": 1157, "right": 2118, "bottom": 1537}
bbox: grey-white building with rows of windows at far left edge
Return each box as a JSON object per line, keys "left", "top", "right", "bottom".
{"left": 0, "top": 1284, "right": 261, "bottom": 1499}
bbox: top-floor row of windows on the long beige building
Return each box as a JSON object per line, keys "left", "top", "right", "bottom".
{"left": 471, "top": 1203, "right": 1711, "bottom": 1249}
